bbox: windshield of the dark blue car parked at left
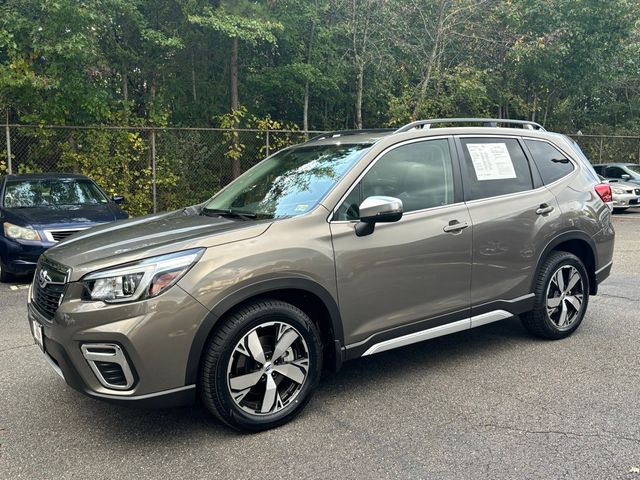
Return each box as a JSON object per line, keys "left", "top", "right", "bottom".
{"left": 3, "top": 179, "right": 109, "bottom": 208}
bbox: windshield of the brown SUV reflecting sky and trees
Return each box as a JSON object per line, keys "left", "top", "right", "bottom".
{"left": 205, "top": 144, "right": 371, "bottom": 218}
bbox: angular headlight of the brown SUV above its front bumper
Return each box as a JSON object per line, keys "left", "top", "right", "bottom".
{"left": 82, "top": 248, "right": 205, "bottom": 303}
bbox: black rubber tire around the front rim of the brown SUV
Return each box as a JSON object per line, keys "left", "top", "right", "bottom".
{"left": 199, "top": 299, "right": 322, "bottom": 432}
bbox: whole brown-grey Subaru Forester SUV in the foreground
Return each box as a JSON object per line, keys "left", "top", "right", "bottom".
{"left": 28, "top": 119, "right": 614, "bottom": 431}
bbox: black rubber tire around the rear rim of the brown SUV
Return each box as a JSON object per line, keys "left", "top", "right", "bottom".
{"left": 520, "top": 251, "right": 589, "bottom": 340}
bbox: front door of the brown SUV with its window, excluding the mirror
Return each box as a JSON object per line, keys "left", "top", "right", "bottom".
{"left": 330, "top": 138, "right": 471, "bottom": 344}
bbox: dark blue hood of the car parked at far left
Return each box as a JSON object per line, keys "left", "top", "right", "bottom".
{"left": 5, "top": 204, "right": 124, "bottom": 229}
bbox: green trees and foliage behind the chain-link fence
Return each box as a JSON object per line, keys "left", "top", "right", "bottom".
{"left": 0, "top": 0, "right": 640, "bottom": 212}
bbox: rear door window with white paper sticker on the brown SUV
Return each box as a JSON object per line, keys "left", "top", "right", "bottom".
{"left": 460, "top": 137, "right": 533, "bottom": 200}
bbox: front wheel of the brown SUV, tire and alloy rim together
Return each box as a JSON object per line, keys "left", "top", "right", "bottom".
{"left": 199, "top": 300, "right": 322, "bottom": 431}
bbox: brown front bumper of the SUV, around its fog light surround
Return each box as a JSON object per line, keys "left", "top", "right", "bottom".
{"left": 28, "top": 283, "right": 208, "bottom": 406}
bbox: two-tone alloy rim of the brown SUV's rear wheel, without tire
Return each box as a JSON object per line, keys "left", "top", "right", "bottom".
{"left": 547, "top": 265, "right": 585, "bottom": 330}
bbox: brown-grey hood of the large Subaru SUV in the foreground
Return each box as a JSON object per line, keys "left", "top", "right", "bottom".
{"left": 44, "top": 209, "right": 273, "bottom": 281}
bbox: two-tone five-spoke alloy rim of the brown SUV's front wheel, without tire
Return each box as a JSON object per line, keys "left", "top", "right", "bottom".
{"left": 227, "top": 322, "right": 309, "bottom": 415}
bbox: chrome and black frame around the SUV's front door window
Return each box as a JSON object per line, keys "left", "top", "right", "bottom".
{"left": 327, "top": 135, "right": 464, "bottom": 223}
